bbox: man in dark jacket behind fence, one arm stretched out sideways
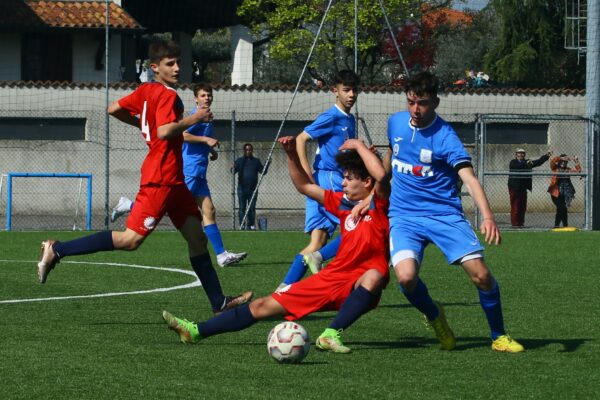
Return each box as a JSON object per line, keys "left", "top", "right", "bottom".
{"left": 508, "top": 149, "right": 552, "bottom": 228}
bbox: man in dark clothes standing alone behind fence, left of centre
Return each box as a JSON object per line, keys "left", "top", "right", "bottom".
{"left": 233, "top": 143, "right": 269, "bottom": 230}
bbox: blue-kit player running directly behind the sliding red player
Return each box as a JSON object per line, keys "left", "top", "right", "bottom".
{"left": 280, "top": 70, "right": 360, "bottom": 287}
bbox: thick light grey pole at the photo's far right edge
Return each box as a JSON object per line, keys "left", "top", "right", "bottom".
{"left": 585, "top": 1, "right": 600, "bottom": 230}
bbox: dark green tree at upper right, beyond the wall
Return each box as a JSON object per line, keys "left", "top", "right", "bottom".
{"left": 485, "top": 0, "right": 585, "bottom": 87}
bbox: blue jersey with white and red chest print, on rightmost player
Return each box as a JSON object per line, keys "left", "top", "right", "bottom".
{"left": 387, "top": 111, "right": 471, "bottom": 218}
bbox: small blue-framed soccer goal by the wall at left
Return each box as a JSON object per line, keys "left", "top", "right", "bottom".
{"left": 0, "top": 172, "right": 92, "bottom": 231}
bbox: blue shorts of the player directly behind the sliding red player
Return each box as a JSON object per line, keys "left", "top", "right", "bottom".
{"left": 304, "top": 170, "right": 344, "bottom": 237}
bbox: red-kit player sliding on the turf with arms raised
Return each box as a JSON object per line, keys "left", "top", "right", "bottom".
{"left": 163, "top": 137, "right": 390, "bottom": 353}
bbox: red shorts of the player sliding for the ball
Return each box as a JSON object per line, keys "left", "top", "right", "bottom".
{"left": 271, "top": 270, "right": 381, "bottom": 321}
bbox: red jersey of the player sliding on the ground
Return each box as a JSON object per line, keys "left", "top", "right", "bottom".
{"left": 320, "top": 190, "right": 390, "bottom": 276}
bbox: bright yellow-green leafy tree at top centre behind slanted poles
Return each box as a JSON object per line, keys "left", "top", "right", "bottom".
{"left": 238, "top": 0, "right": 422, "bottom": 83}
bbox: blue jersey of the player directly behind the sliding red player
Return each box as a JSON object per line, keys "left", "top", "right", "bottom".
{"left": 304, "top": 105, "right": 356, "bottom": 171}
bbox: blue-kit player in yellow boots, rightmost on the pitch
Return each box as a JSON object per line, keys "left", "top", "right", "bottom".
{"left": 386, "top": 72, "right": 525, "bottom": 353}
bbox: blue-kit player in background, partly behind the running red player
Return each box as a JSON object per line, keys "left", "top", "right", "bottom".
{"left": 182, "top": 83, "right": 247, "bottom": 267}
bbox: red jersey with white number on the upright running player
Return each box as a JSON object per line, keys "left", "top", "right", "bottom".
{"left": 119, "top": 82, "right": 184, "bottom": 186}
